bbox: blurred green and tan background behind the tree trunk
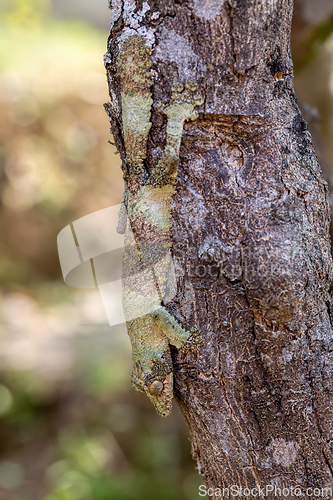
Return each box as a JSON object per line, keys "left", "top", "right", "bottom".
{"left": 0, "top": 0, "right": 333, "bottom": 500}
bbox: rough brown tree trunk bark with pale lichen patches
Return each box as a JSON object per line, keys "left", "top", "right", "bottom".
{"left": 106, "top": 0, "right": 333, "bottom": 498}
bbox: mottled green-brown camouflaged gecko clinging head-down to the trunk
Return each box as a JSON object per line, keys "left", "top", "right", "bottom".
{"left": 117, "top": 35, "right": 203, "bottom": 416}
